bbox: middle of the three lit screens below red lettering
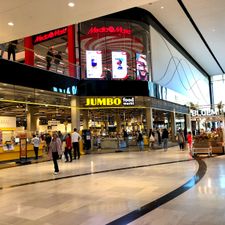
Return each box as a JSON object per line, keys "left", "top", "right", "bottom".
{"left": 112, "top": 52, "right": 127, "bottom": 79}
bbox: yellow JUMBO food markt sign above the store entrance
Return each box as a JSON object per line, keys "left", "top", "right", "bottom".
{"left": 85, "top": 97, "right": 135, "bottom": 106}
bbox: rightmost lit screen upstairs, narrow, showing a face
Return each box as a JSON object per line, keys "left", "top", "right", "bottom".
{"left": 136, "top": 53, "right": 149, "bottom": 80}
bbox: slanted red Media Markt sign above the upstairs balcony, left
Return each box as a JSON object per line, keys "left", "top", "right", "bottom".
{"left": 33, "top": 27, "right": 67, "bottom": 44}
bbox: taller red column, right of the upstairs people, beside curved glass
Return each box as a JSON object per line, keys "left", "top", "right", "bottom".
{"left": 67, "top": 25, "right": 76, "bottom": 77}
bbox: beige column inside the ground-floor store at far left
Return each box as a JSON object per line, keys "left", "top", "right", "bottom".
{"left": 27, "top": 105, "right": 39, "bottom": 132}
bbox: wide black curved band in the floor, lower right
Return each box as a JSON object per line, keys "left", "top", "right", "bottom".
{"left": 107, "top": 158, "right": 207, "bottom": 225}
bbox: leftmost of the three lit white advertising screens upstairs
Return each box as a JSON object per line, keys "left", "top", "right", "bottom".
{"left": 86, "top": 51, "right": 102, "bottom": 78}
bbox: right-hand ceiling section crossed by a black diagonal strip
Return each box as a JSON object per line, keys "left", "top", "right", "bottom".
{"left": 142, "top": 0, "right": 225, "bottom": 75}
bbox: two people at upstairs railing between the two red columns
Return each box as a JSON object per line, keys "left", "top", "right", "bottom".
{"left": 46, "top": 47, "right": 62, "bottom": 72}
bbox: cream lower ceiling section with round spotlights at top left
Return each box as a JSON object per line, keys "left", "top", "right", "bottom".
{"left": 0, "top": 0, "right": 157, "bottom": 43}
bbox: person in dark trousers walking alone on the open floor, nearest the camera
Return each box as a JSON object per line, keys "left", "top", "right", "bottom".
{"left": 49, "top": 133, "right": 62, "bottom": 175}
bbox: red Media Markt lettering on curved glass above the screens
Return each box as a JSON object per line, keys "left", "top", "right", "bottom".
{"left": 88, "top": 26, "right": 131, "bottom": 34}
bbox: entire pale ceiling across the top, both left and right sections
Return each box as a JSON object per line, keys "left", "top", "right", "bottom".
{"left": 0, "top": 0, "right": 225, "bottom": 75}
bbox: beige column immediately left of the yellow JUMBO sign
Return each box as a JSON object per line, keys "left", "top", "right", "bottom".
{"left": 71, "top": 96, "right": 80, "bottom": 131}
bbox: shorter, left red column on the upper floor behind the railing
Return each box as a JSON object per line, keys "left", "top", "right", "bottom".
{"left": 24, "top": 37, "right": 34, "bottom": 66}
